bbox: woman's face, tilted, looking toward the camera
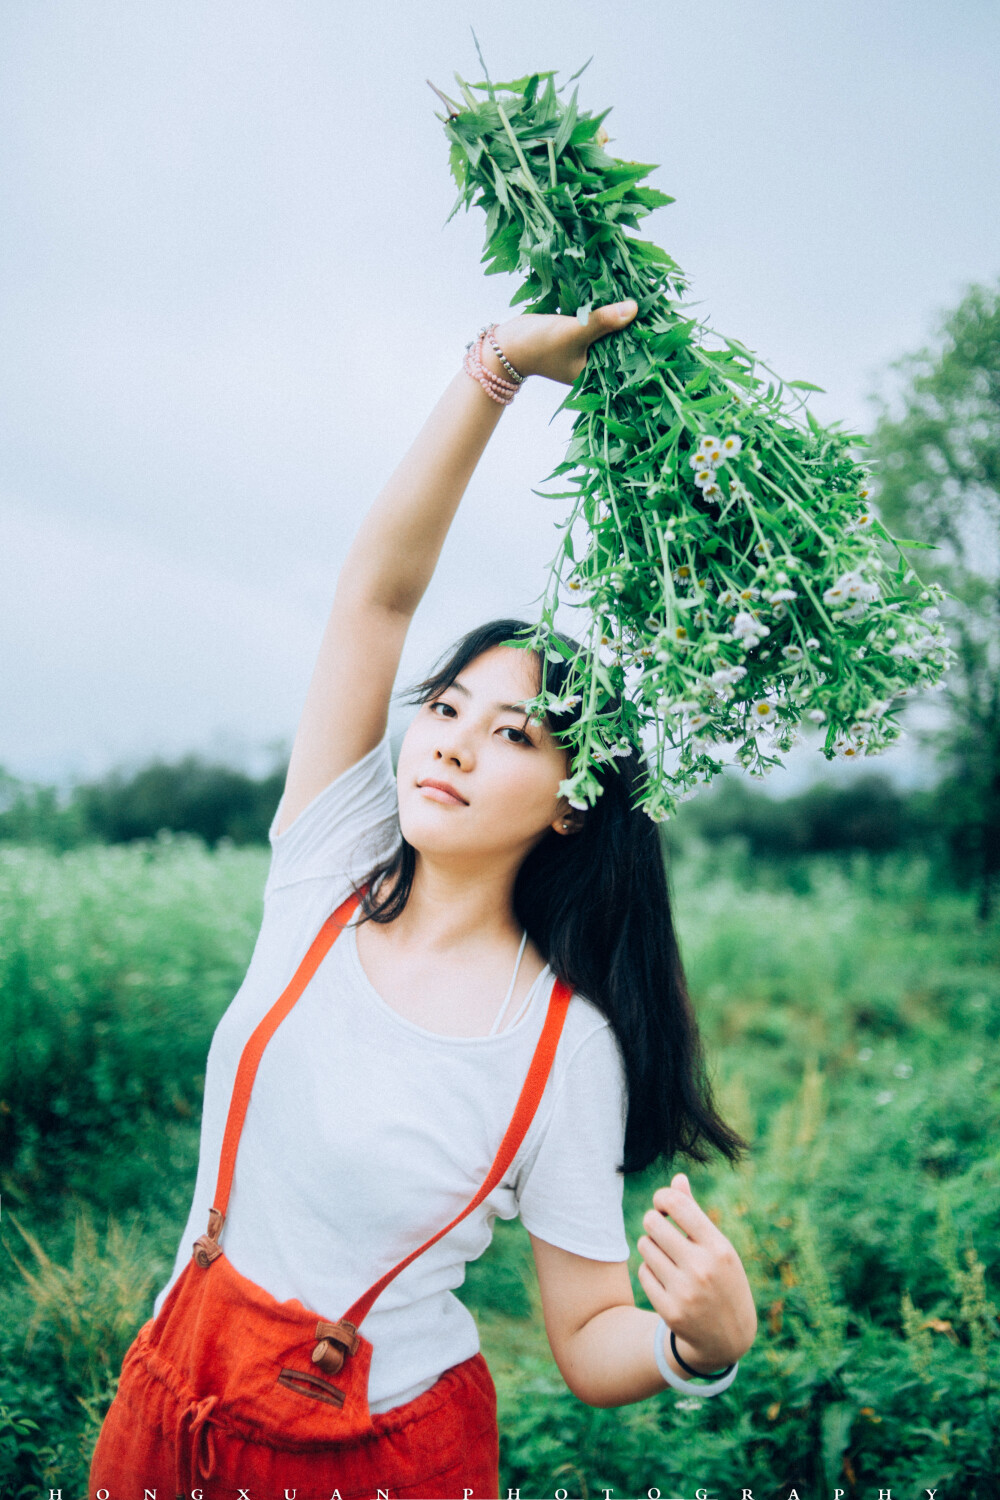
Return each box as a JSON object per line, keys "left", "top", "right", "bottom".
{"left": 396, "top": 647, "right": 580, "bottom": 855}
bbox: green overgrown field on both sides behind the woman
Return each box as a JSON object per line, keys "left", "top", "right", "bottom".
{"left": 0, "top": 836, "right": 1000, "bottom": 1500}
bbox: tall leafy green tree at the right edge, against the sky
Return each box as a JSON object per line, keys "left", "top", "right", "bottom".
{"left": 871, "top": 282, "right": 1000, "bottom": 921}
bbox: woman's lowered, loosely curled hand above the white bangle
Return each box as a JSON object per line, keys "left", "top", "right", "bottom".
{"left": 636, "top": 1172, "right": 757, "bottom": 1374}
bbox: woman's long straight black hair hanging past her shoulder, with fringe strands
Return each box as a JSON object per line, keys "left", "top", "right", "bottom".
{"left": 347, "top": 620, "right": 747, "bottom": 1173}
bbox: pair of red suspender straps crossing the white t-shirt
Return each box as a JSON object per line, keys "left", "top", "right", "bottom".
{"left": 195, "top": 893, "right": 573, "bottom": 1328}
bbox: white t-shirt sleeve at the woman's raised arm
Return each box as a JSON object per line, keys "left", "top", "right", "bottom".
{"left": 264, "top": 728, "right": 399, "bottom": 900}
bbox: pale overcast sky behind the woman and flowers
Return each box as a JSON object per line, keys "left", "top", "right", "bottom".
{"left": 0, "top": 0, "right": 1000, "bottom": 791}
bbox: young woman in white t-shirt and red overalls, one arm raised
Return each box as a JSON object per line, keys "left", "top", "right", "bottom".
{"left": 90, "top": 303, "right": 757, "bottom": 1500}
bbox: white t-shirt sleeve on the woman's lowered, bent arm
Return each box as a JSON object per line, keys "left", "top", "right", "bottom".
{"left": 516, "top": 1025, "right": 630, "bottom": 1260}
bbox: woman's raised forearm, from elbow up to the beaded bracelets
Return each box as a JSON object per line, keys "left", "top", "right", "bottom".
{"left": 337, "top": 348, "right": 505, "bottom": 615}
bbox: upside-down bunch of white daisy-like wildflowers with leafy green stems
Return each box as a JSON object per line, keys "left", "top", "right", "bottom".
{"left": 432, "top": 55, "right": 949, "bottom": 822}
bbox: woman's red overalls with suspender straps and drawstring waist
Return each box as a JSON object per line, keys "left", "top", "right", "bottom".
{"left": 88, "top": 894, "right": 573, "bottom": 1500}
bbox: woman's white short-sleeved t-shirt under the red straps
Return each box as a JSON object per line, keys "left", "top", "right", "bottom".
{"left": 153, "top": 731, "right": 630, "bottom": 1412}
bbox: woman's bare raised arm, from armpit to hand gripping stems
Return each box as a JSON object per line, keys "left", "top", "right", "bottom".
{"left": 277, "top": 303, "right": 636, "bottom": 834}
